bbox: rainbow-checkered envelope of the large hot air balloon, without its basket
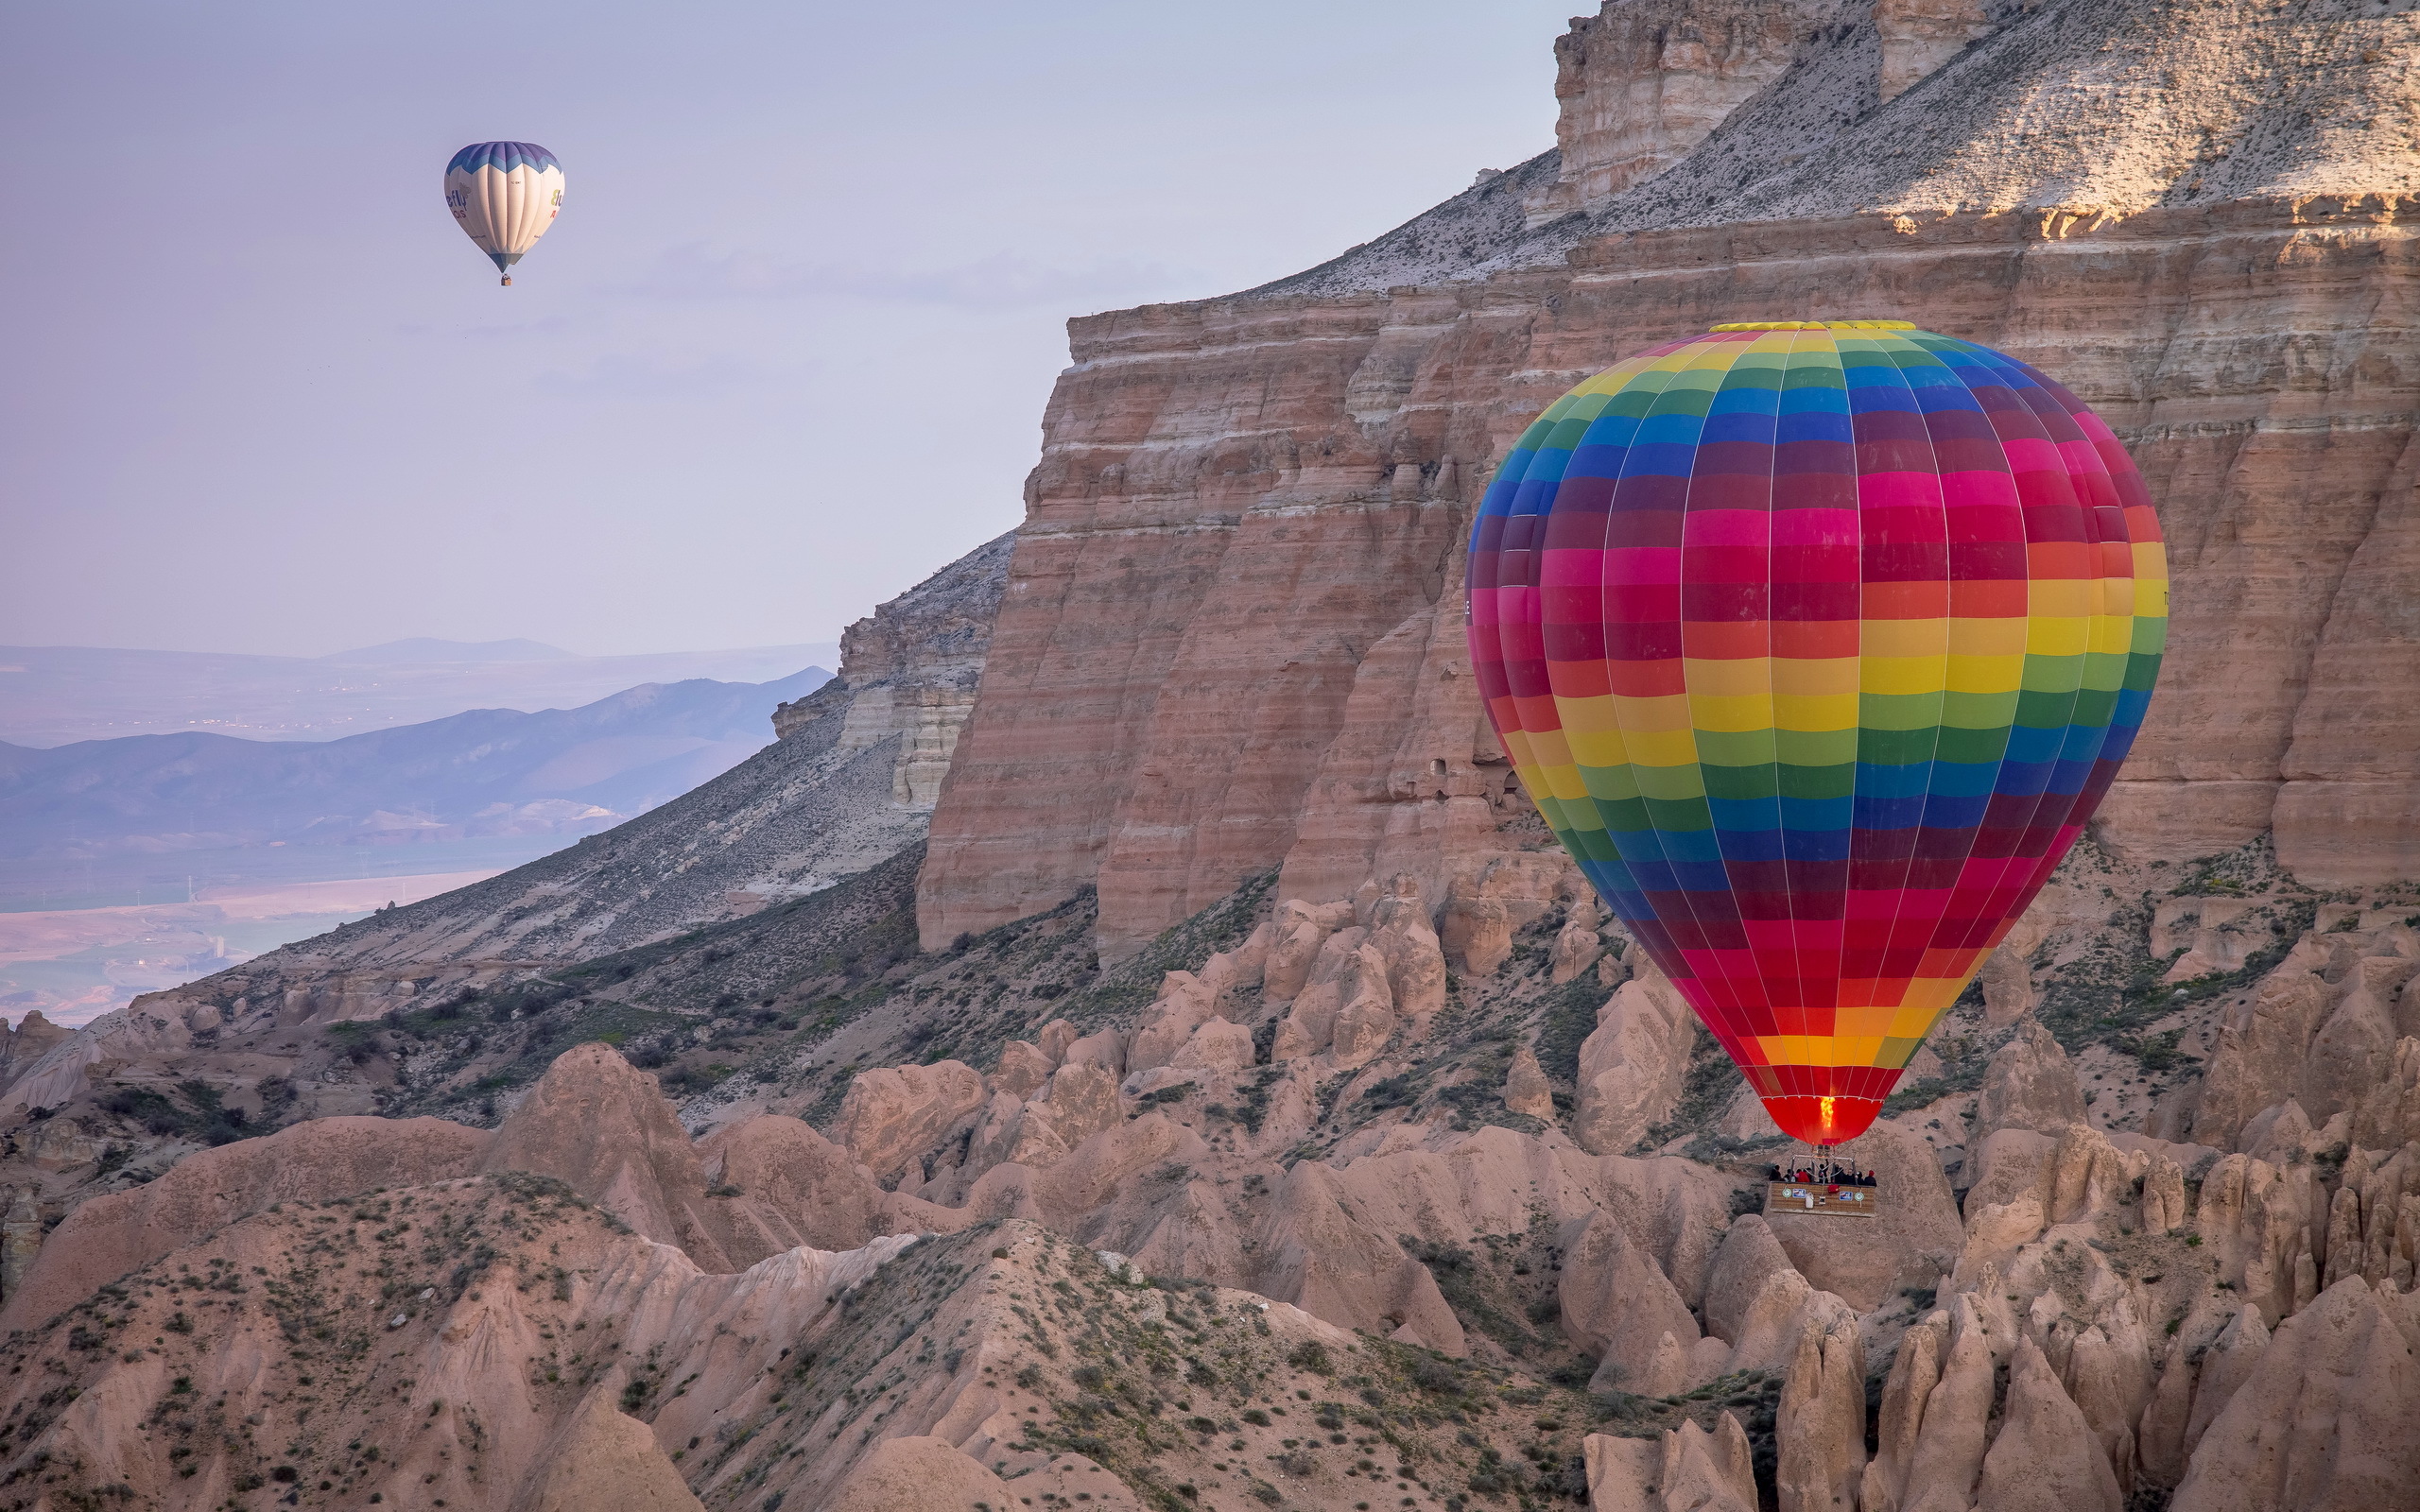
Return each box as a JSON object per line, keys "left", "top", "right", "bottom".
{"left": 1469, "top": 319, "right": 2169, "bottom": 1144}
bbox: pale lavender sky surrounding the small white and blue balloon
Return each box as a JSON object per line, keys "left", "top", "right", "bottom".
{"left": 0, "top": 0, "right": 1573, "bottom": 656}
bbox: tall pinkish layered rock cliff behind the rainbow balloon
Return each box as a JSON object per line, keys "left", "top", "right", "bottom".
{"left": 920, "top": 3, "right": 2420, "bottom": 955}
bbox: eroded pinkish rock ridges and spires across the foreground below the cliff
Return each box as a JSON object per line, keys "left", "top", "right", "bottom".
{"left": 0, "top": 847, "right": 2420, "bottom": 1512}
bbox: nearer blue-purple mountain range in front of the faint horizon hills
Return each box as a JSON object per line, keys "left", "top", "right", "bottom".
{"left": 0, "top": 658, "right": 830, "bottom": 859}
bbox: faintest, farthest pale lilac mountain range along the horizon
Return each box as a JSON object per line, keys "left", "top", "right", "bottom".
{"left": 0, "top": 639, "right": 839, "bottom": 747}
